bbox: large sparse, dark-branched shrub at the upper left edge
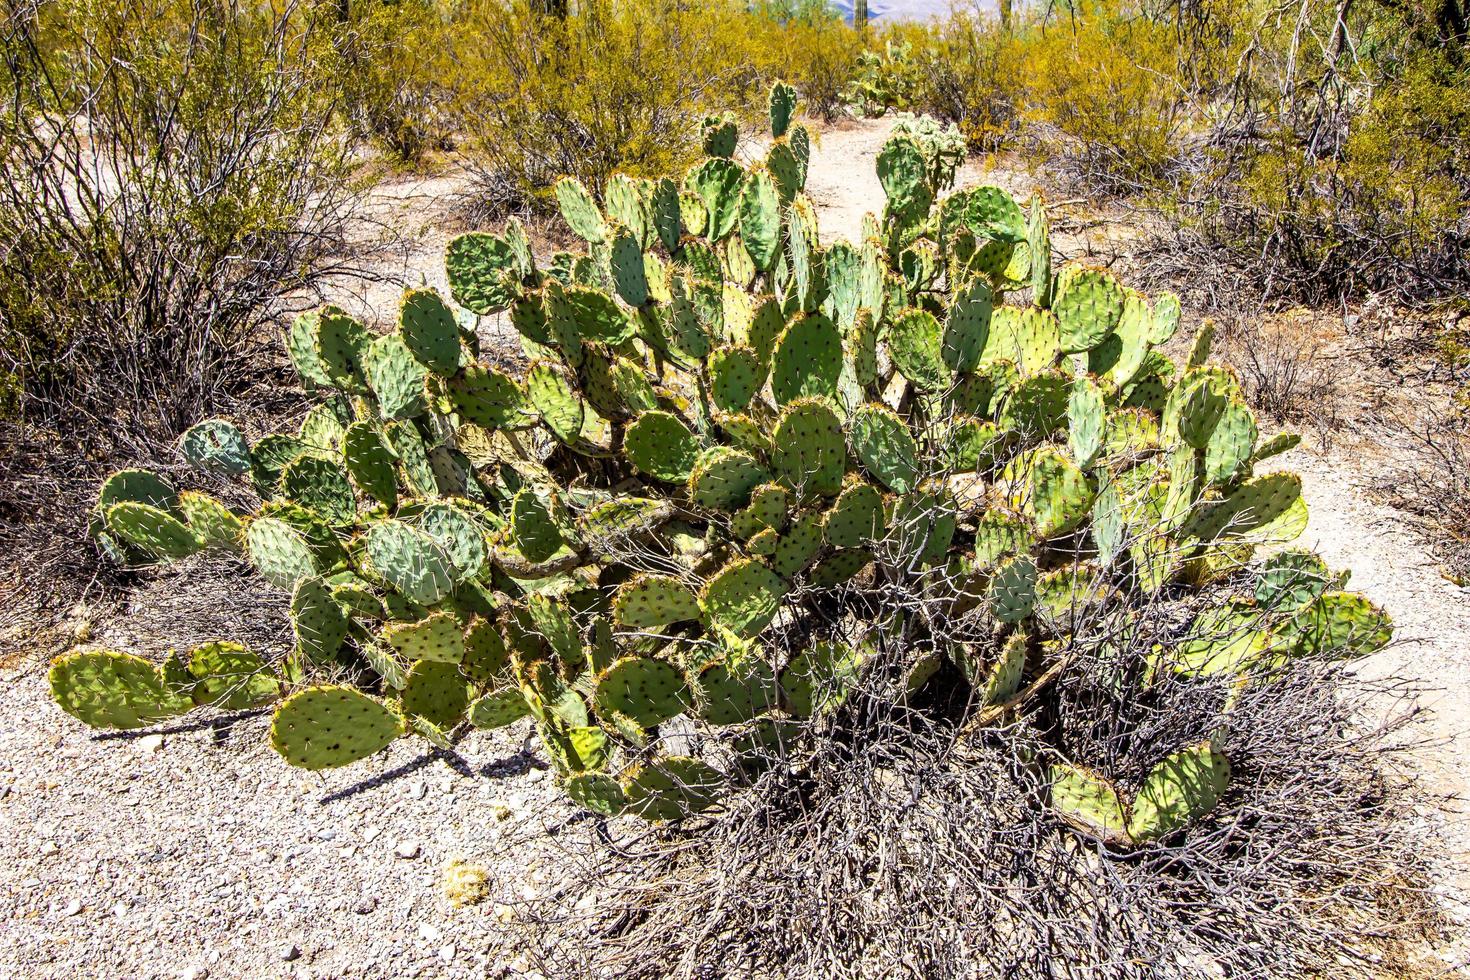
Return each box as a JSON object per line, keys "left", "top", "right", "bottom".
{"left": 0, "top": 0, "right": 348, "bottom": 442}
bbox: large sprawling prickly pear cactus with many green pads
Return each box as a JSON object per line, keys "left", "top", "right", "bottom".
{"left": 51, "top": 85, "right": 1389, "bottom": 842}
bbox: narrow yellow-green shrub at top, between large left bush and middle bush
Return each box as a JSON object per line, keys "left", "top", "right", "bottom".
{"left": 312, "top": 0, "right": 454, "bottom": 163}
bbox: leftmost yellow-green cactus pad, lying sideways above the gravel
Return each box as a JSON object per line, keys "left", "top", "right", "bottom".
{"left": 49, "top": 651, "right": 194, "bottom": 729}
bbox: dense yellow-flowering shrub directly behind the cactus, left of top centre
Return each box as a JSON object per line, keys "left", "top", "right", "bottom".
{"left": 451, "top": 0, "right": 757, "bottom": 214}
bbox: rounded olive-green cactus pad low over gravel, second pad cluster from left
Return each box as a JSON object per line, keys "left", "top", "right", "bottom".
{"left": 270, "top": 685, "right": 403, "bottom": 770}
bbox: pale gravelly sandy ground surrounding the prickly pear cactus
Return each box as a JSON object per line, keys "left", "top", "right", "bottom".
{"left": 0, "top": 123, "right": 1470, "bottom": 980}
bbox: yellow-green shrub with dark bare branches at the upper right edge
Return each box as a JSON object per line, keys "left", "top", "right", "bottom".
{"left": 1186, "top": 3, "right": 1470, "bottom": 300}
